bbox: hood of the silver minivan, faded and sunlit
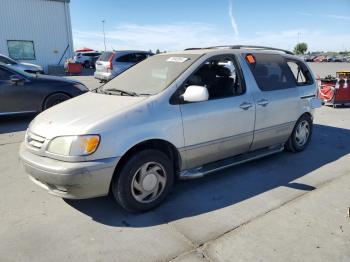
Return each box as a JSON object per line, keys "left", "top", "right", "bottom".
{"left": 29, "top": 92, "right": 147, "bottom": 139}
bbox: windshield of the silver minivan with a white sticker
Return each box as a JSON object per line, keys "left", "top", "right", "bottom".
{"left": 102, "top": 54, "right": 200, "bottom": 95}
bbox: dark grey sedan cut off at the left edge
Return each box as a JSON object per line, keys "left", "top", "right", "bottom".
{"left": 0, "top": 63, "right": 88, "bottom": 116}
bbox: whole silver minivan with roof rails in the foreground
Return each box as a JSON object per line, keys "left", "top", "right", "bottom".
{"left": 20, "top": 46, "right": 321, "bottom": 211}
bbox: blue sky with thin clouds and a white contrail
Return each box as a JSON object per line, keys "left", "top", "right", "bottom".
{"left": 70, "top": 0, "right": 350, "bottom": 51}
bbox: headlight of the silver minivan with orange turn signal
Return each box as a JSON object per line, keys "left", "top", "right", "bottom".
{"left": 47, "top": 135, "right": 100, "bottom": 156}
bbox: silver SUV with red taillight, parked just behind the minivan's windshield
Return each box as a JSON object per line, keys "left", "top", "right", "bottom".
{"left": 94, "top": 50, "right": 153, "bottom": 82}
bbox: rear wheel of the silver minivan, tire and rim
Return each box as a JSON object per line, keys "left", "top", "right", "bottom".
{"left": 285, "top": 114, "right": 313, "bottom": 153}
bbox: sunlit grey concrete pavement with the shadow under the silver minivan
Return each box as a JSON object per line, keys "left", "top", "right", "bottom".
{"left": 0, "top": 63, "right": 350, "bottom": 261}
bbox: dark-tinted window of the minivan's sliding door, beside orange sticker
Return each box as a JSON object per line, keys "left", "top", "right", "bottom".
{"left": 249, "top": 53, "right": 296, "bottom": 91}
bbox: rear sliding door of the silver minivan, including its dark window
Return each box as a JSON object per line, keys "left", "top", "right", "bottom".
{"left": 250, "top": 53, "right": 300, "bottom": 150}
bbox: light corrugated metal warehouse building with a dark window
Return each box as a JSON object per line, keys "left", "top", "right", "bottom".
{"left": 0, "top": 0, "right": 73, "bottom": 70}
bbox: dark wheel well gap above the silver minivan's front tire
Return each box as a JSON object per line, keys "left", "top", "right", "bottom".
{"left": 114, "top": 139, "right": 181, "bottom": 180}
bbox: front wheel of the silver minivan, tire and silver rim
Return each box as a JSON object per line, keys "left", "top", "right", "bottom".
{"left": 111, "top": 149, "right": 174, "bottom": 213}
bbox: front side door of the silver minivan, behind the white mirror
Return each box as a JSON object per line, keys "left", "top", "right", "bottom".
{"left": 180, "top": 56, "right": 255, "bottom": 168}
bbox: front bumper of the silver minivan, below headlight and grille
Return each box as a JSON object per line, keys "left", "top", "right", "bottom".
{"left": 20, "top": 143, "right": 119, "bottom": 199}
